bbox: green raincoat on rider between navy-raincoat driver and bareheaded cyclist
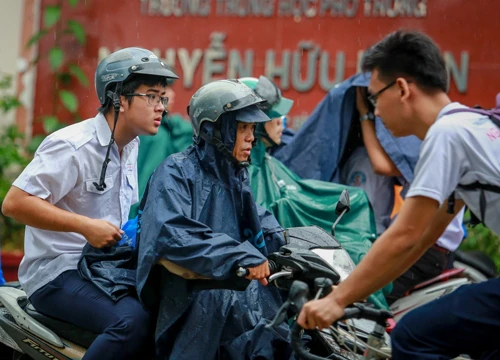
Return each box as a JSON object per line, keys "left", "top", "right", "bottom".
{"left": 248, "top": 140, "right": 392, "bottom": 308}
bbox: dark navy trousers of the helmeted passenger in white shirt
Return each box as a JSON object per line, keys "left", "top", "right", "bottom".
{"left": 30, "top": 270, "right": 150, "bottom": 360}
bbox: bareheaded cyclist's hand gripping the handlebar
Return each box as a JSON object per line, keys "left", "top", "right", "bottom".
{"left": 297, "top": 293, "right": 344, "bottom": 329}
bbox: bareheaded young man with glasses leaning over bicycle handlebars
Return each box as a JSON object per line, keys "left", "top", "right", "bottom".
{"left": 298, "top": 31, "right": 500, "bottom": 360}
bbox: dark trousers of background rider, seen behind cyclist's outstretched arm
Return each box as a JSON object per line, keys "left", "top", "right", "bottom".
{"left": 386, "top": 246, "right": 453, "bottom": 305}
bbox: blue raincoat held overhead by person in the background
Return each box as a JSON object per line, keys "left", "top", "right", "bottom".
{"left": 273, "top": 74, "right": 421, "bottom": 183}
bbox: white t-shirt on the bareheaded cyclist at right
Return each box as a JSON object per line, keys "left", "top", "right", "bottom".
{"left": 407, "top": 103, "right": 500, "bottom": 234}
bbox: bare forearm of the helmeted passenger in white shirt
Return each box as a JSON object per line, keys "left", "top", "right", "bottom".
{"left": 2, "top": 187, "right": 88, "bottom": 234}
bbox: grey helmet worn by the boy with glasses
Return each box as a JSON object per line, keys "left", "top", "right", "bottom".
{"left": 95, "top": 47, "right": 179, "bottom": 105}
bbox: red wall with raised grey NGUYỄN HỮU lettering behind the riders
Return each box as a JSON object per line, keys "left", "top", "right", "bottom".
{"left": 31, "top": 0, "right": 500, "bottom": 131}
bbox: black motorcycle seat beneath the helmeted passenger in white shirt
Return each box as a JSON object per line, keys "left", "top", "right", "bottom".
{"left": 25, "top": 303, "right": 99, "bottom": 348}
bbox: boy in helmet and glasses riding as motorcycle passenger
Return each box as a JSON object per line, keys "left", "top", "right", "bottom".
{"left": 2, "top": 48, "right": 177, "bottom": 359}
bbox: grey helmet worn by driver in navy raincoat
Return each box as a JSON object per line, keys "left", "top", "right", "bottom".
{"left": 188, "top": 79, "right": 269, "bottom": 136}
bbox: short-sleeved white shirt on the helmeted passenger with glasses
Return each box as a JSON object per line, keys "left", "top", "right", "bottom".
{"left": 13, "top": 114, "right": 139, "bottom": 296}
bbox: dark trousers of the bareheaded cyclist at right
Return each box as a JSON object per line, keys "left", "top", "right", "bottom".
{"left": 391, "top": 278, "right": 500, "bottom": 360}
